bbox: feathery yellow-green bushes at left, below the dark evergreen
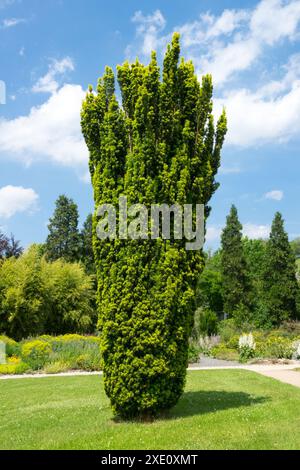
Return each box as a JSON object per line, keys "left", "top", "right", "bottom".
{"left": 0, "top": 246, "right": 94, "bottom": 339}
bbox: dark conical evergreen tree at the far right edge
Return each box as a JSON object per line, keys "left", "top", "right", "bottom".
{"left": 263, "top": 212, "right": 299, "bottom": 325}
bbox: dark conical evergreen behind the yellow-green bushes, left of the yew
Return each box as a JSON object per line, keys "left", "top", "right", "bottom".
{"left": 46, "top": 195, "right": 80, "bottom": 262}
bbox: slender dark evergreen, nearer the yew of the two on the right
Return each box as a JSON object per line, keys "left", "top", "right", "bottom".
{"left": 221, "top": 206, "right": 251, "bottom": 324}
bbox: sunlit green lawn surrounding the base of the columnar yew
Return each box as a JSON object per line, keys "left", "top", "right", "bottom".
{"left": 0, "top": 370, "right": 300, "bottom": 450}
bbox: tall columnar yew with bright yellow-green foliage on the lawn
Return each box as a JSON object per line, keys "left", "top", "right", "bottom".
{"left": 82, "top": 34, "right": 226, "bottom": 417}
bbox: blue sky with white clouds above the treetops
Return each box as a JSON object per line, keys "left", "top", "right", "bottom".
{"left": 0, "top": 0, "right": 300, "bottom": 248}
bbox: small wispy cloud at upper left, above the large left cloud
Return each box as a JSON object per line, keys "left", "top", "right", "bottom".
{"left": 32, "top": 57, "right": 74, "bottom": 93}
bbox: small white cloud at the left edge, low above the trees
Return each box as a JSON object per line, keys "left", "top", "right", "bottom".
{"left": 0, "top": 186, "right": 38, "bottom": 219}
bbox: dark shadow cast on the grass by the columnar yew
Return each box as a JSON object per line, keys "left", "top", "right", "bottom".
{"left": 161, "top": 390, "right": 270, "bottom": 419}
